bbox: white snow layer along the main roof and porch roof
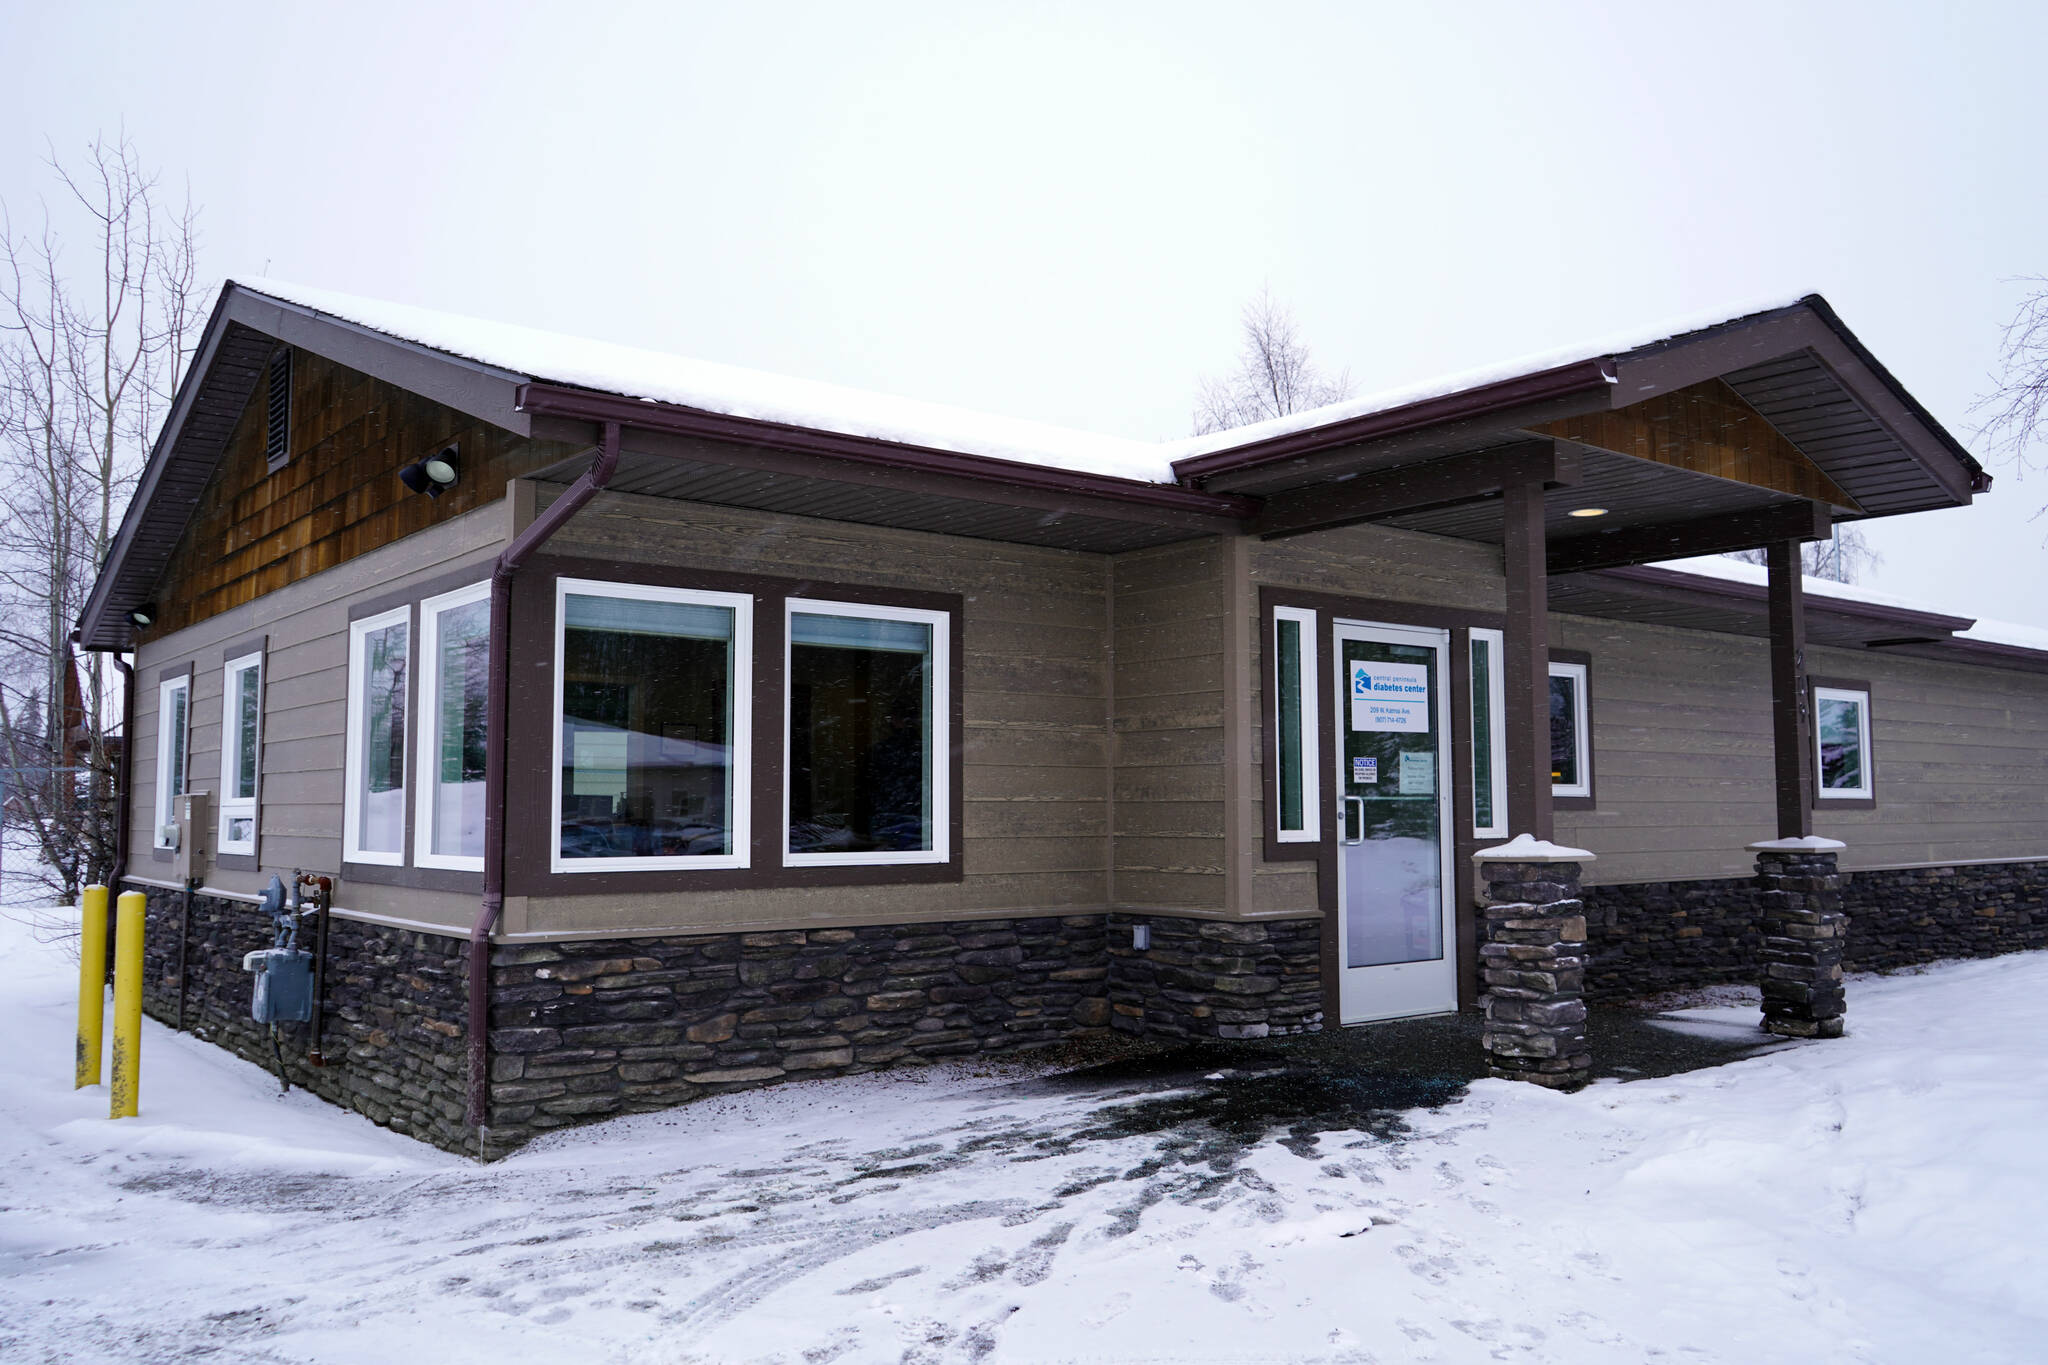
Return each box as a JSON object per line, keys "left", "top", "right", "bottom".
{"left": 238, "top": 278, "right": 1798, "bottom": 485}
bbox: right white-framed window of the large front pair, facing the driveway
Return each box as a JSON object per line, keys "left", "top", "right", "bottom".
{"left": 782, "top": 598, "right": 952, "bottom": 868}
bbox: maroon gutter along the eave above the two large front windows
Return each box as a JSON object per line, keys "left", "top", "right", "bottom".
{"left": 518, "top": 383, "right": 1260, "bottom": 522}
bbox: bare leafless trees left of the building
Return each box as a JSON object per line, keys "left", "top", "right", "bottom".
{"left": 0, "top": 135, "right": 205, "bottom": 898}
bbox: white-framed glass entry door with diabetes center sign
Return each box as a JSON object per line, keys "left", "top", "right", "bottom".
{"left": 1331, "top": 622, "right": 1458, "bottom": 1023}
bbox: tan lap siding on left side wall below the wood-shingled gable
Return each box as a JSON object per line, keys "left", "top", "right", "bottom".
{"left": 129, "top": 505, "right": 506, "bottom": 927}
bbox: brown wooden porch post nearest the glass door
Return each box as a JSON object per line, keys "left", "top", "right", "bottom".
{"left": 1501, "top": 483, "right": 1552, "bottom": 843}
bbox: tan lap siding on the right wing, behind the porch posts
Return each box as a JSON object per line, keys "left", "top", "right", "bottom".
{"left": 1554, "top": 616, "right": 2048, "bottom": 884}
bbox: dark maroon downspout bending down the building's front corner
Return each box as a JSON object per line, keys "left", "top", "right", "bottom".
{"left": 469, "top": 422, "right": 618, "bottom": 1130}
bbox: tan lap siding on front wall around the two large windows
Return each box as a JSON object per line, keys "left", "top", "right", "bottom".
{"left": 524, "top": 489, "right": 1110, "bottom": 933}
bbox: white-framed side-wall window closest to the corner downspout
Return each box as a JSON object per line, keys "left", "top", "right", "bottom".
{"left": 412, "top": 581, "right": 492, "bottom": 872}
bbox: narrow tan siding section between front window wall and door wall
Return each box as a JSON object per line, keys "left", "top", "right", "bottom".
{"left": 1110, "top": 540, "right": 1231, "bottom": 913}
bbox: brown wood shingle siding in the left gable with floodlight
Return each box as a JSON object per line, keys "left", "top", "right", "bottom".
{"left": 144, "top": 350, "right": 573, "bottom": 636}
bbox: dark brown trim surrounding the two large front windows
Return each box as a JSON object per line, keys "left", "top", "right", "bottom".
{"left": 506, "top": 555, "right": 965, "bottom": 896}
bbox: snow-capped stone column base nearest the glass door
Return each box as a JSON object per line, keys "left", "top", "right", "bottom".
{"left": 1473, "top": 835, "right": 1593, "bottom": 1091}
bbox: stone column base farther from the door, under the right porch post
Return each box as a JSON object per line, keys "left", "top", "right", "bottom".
{"left": 1749, "top": 835, "right": 1849, "bottom": 1038}
